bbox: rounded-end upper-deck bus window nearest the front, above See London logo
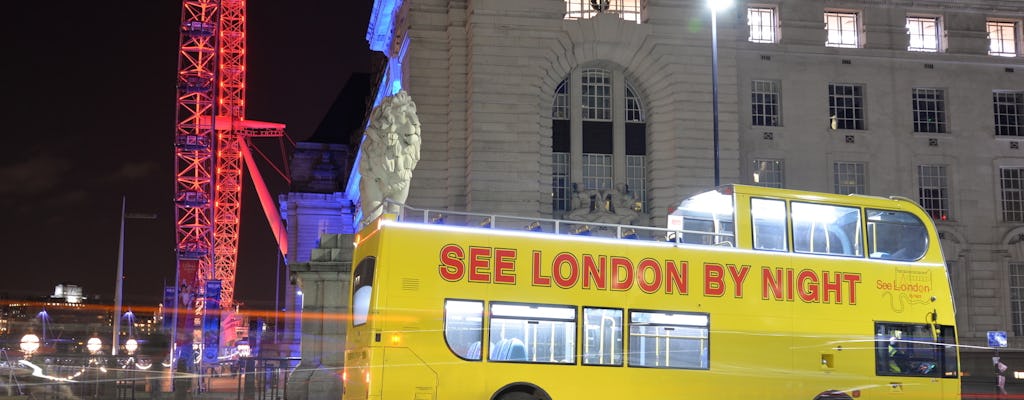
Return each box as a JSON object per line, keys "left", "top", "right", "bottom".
{"left": 867, "top": 210, "right": 928, "bottom": 261}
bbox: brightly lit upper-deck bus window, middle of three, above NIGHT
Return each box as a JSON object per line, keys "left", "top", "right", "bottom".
{"left": 793, "top": 202, "right": 862, "bottom": 256}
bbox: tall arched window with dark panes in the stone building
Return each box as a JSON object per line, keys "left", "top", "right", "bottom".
{"left": 551, "top": 66, "right": 647, "bottom": 217}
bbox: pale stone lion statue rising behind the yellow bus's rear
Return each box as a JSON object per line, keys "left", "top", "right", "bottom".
{"left": 359, "top": 90, "right": 421, "bottom": 224}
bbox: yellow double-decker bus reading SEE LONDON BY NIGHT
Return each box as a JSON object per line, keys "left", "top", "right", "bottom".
{"left": 343, "top": 185, "right": 961, "bottom": 400}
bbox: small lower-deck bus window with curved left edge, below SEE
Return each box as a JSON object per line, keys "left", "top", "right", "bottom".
{"left": 444, "top": 300, "right": 489, "bottom": 361}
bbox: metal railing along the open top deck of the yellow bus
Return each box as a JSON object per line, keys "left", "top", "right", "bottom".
{"left": 386, "top": 201, "right": 735, "bottom": 247}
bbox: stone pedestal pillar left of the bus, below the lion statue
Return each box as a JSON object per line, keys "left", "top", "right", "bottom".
{"left": 286, "top": 233, "right": 352, "bottom": 400}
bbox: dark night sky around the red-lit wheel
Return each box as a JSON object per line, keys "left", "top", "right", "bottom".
{"left": 0, "top": 0, "right": 372, "bottom": 308}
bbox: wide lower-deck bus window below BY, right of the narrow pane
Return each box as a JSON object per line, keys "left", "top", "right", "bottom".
{"left": 629, "top": 311, "right": 709, "bottom": 369}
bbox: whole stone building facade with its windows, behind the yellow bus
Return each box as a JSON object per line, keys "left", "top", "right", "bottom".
{"left": 364, "top": 0, "right": 1024, "bottom": 372}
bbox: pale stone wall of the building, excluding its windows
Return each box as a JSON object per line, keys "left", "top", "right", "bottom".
{"left": 374, "top": 0, "right": 1024, "bottom": 360}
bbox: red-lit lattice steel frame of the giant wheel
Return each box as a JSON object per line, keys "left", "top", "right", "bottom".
{"left": 174, "top": 0, "right": 287, "bottom": 360}
